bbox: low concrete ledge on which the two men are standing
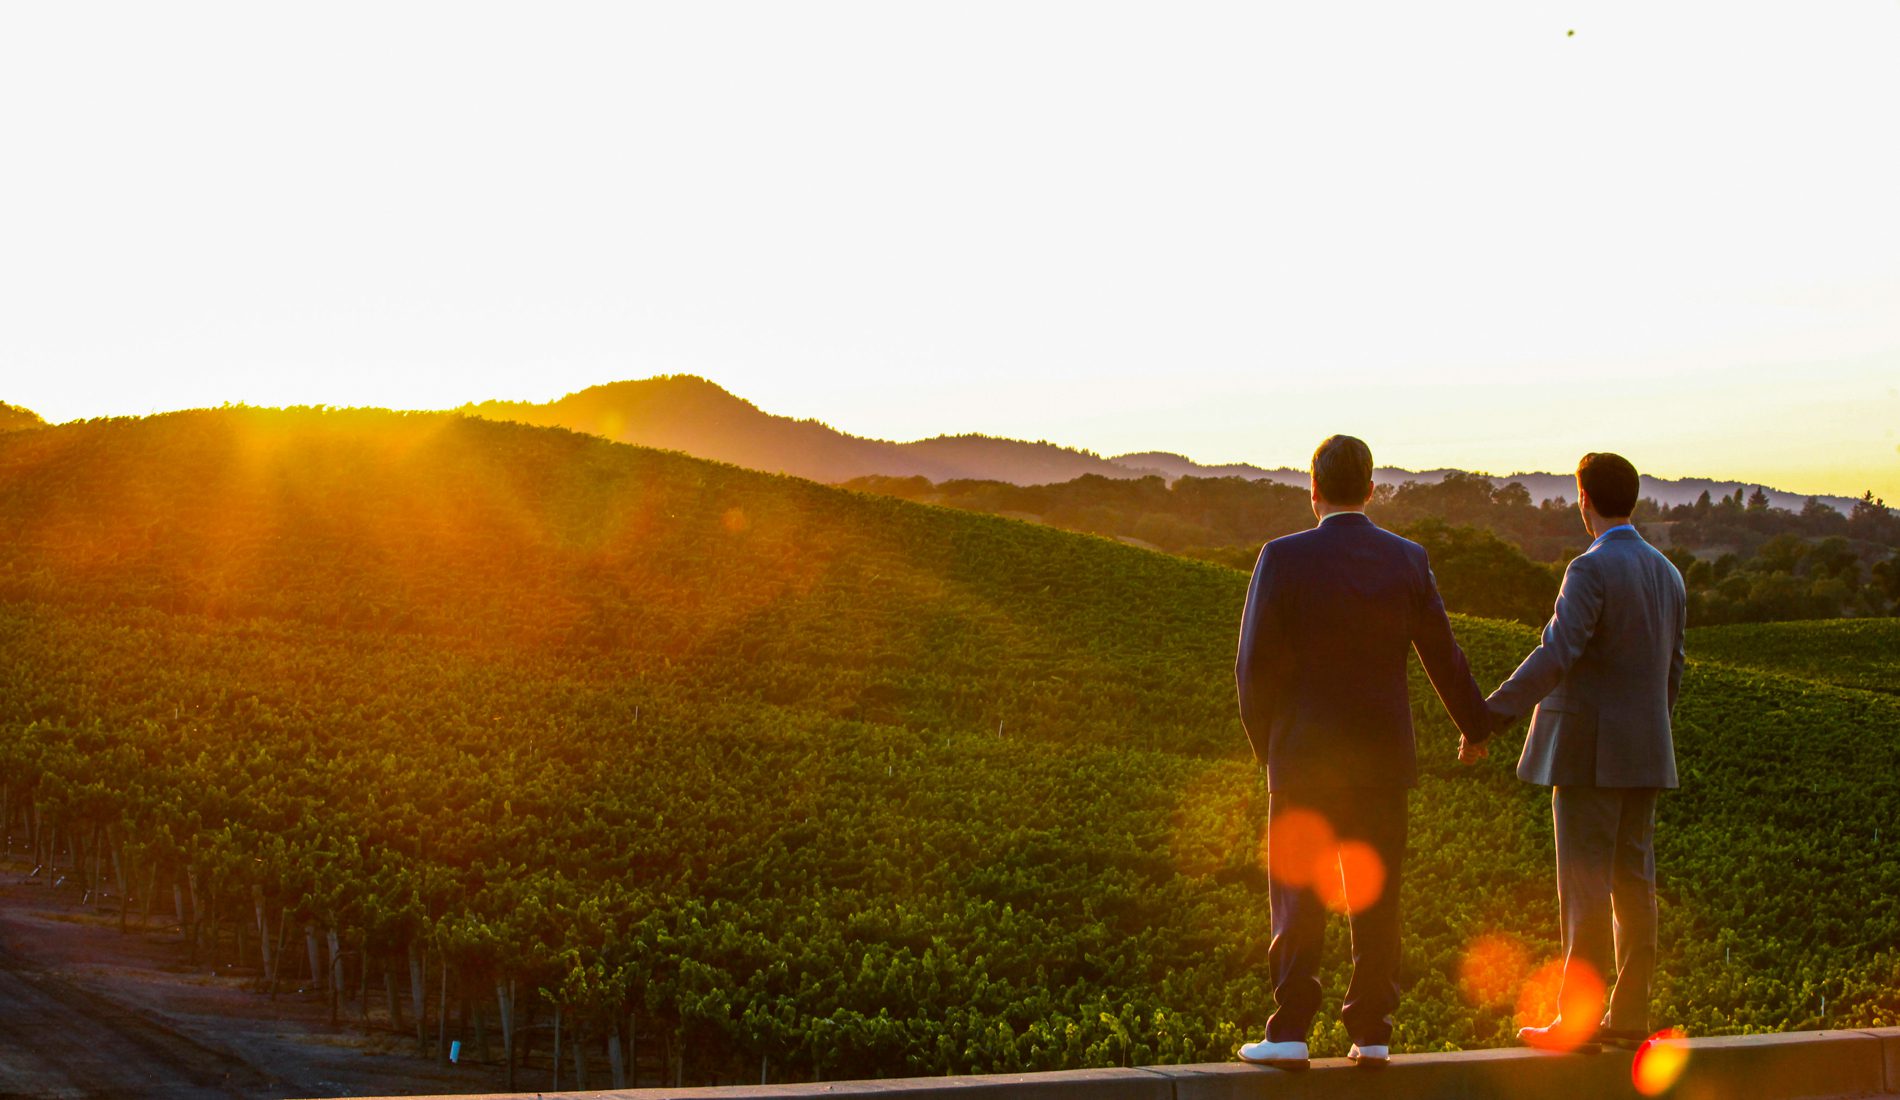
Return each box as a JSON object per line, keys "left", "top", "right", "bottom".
{"left": 349, "top": 1028, "right": 1900, "bottom": 1100}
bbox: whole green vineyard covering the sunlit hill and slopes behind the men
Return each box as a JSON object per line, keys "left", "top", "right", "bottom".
{"left": 0, "top": 408, "right": 1900, "bottom": 1085}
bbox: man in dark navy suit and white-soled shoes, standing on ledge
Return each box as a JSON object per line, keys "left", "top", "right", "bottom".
{"left": 1235, "top": 435, "right": 1493, "bottom": 1070}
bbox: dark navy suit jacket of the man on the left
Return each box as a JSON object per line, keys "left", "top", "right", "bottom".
{"left": 1233, "top": 511, "right": 1492, "bottom": 790}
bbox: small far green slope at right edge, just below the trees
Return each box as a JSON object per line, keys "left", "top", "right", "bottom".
{"left": 1689, "top": 617, "right": 1900, "bottom": 693}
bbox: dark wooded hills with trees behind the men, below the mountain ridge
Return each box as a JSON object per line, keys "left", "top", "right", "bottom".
{"left": 846, "top": 471, "right": 1900, "bottom": 625}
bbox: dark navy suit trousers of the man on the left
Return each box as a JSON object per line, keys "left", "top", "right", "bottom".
{"left": 1267, "top": 787, "right": 1406, "bottom": 1047}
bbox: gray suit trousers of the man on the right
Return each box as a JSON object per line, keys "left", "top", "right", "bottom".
{"left": 1550, "top": 787, "right": 1657, "bottom": 1032}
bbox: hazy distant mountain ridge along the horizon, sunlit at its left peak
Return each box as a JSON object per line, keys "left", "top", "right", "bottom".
{"left": 456, "top": 374, "right": 1853, "bottom": 515}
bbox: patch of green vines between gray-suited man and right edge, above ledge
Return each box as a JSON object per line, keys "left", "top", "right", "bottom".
{"left": 1657, "top": 668, "right": 1900, "bottom": 1034}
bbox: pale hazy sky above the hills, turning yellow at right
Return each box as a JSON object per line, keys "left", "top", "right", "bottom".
{"left": 0, "top": 0, "right": 1900, "bottom": 502}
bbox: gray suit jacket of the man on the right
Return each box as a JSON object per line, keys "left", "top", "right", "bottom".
{"left": 1488, "top": 530, "right": 1687, "bottom": 787}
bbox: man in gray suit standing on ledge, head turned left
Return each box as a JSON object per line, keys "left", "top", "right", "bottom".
{"left": 1459, "top": 454, "right": 1687, "bottom": 1049}
